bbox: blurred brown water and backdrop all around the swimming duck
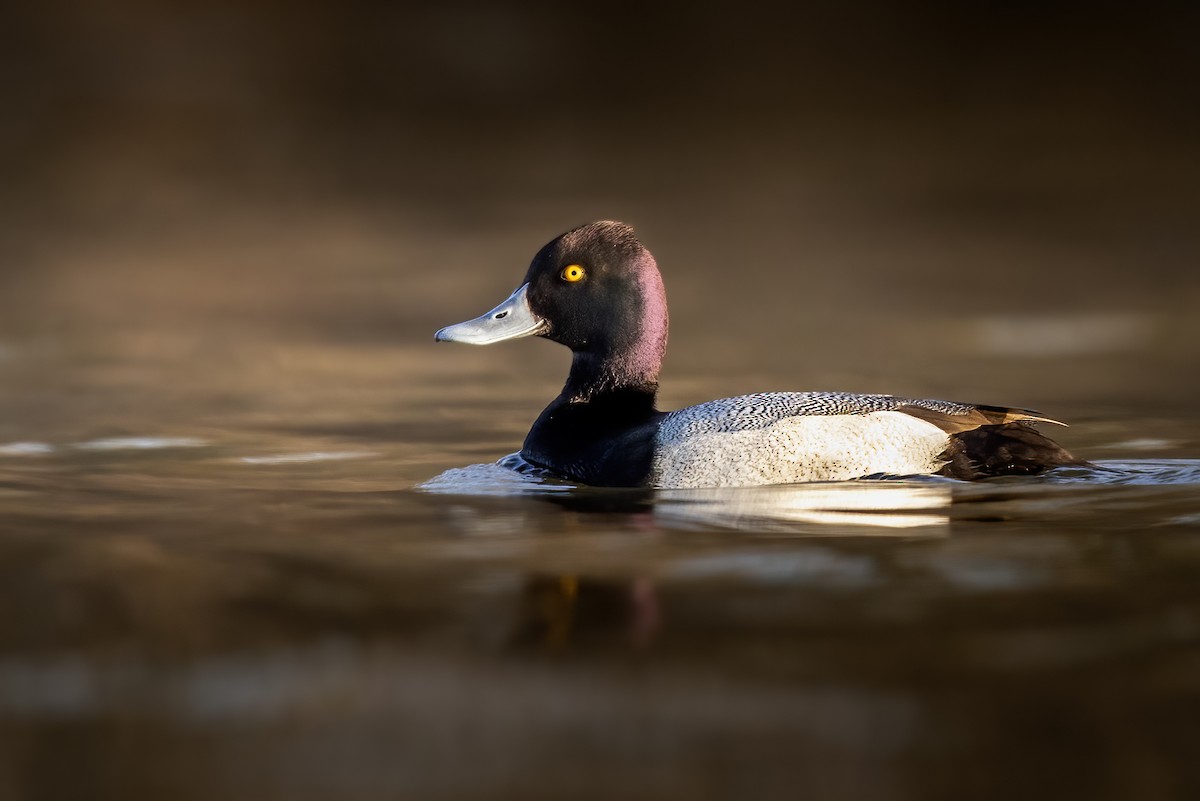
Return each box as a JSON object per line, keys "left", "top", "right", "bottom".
{"left": 0, "top": 0, "right": 1200, "bottom": 801}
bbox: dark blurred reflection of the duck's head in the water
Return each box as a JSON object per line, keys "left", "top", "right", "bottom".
{"left": 510, "top": 574, "right": 662, "bottom": 652}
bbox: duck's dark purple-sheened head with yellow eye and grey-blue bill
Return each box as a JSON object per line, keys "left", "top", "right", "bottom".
{"left": 437, "top": 221, "right": 667, "bottom": 396}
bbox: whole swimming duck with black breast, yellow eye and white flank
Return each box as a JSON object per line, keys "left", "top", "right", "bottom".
{"left": 434, "top": 221, "right": 1085, "bottom": 489}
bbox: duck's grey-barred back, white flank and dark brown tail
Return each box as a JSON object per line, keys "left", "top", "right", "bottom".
{"left": 652, "top": 392, "right": 1075, "bottom": 487}
